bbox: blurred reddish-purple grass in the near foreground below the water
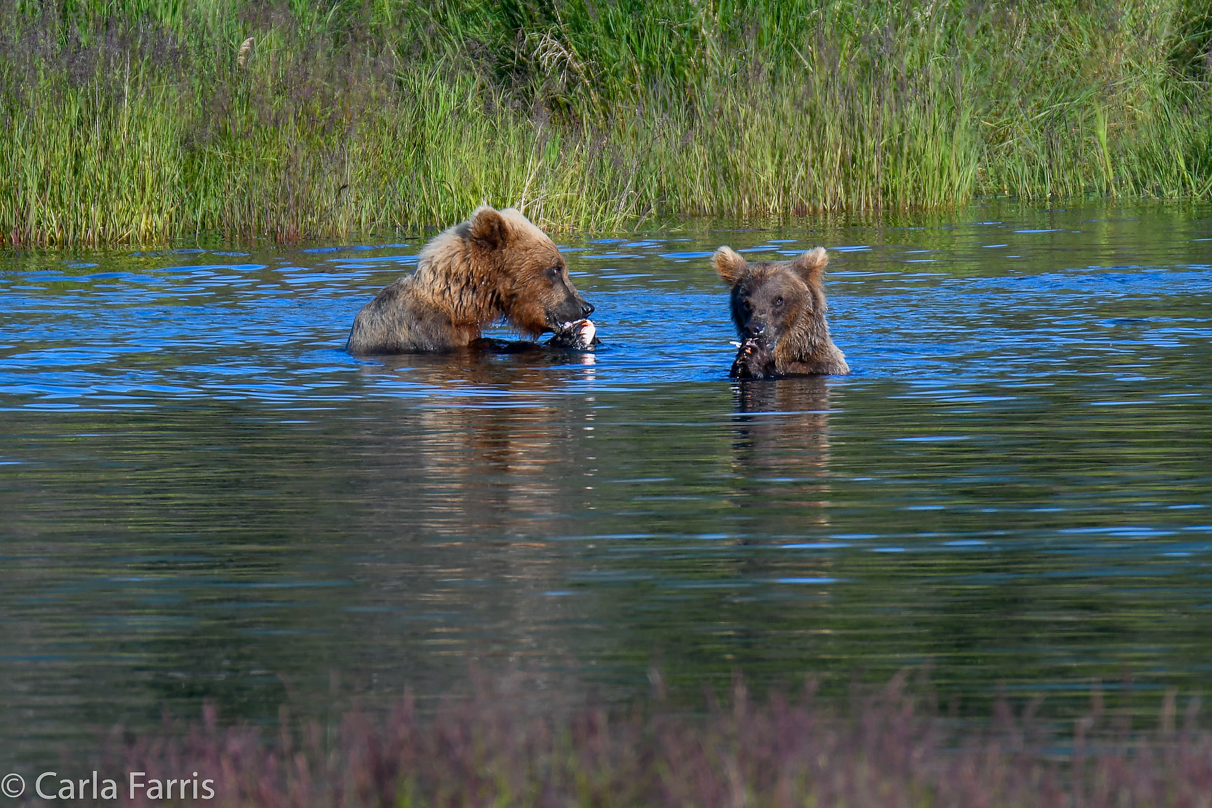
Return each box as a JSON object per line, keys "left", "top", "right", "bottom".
{"left": 101, "top": 676, "right": 1212, "bottom": 808}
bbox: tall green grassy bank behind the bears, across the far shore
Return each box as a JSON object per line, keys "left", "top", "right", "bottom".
{"left": 0, "top": 0, "right": 1212, "bottom": 245}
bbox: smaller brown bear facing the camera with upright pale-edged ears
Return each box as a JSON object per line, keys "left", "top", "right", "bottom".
{"left": 711, "top": 247, "right": 850, "bottom": 379}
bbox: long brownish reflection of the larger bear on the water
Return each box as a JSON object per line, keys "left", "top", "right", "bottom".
{"left": 350, "top": 349, "right": 599, "bottom": 692}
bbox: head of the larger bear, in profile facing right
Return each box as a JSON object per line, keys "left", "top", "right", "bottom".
{"left": 464, "top": 207, "right": 594, "bottom": 337}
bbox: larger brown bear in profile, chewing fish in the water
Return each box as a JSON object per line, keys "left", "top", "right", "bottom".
{"left": 345, "top": 206, "right": 594, "bottom": 354}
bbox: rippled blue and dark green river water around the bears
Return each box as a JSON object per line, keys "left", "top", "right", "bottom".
{"left": 0, "top": 205, "right": 1212, "bottom": 764}
